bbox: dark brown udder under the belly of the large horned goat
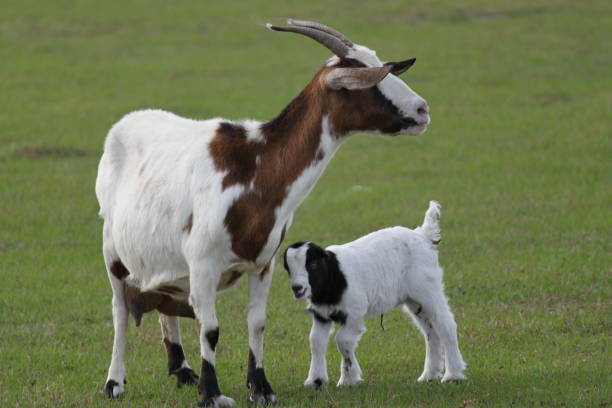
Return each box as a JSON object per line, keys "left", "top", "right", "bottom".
{"left": 125, "top": 283, "right": 195, "bottom": 326}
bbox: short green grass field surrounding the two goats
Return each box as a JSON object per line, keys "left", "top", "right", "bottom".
{"left": 0, "top": 0, "right": 612, "bottom": 407}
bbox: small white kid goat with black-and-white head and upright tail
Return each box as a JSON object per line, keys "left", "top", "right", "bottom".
{"left": 284, "top": 201, "right": 465, "bottom": 387}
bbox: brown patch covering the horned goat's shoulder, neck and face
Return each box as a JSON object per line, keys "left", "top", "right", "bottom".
{"left": 209, "top": 59, "right": 401, "bottom": 261}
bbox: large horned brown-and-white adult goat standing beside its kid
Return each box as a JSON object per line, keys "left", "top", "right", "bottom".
{"left": 96, "top": 20, "right": 430, "bottom": 406}
